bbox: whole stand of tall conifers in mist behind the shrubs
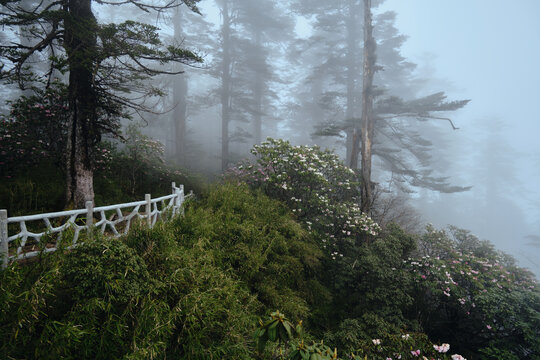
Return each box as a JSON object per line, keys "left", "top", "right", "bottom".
{"left": 0, "top": 0, "right": 536, "bottom": 272}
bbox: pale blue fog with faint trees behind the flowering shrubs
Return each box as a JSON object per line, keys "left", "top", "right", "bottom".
{"left": 0, "top": 0, "right": 540, "bottom": 276}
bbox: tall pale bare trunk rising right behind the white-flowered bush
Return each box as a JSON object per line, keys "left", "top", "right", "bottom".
{"left": 351, "top": 0, "right": 376, "bottom": 213}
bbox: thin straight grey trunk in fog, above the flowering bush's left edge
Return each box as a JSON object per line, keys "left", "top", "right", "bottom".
{"left": 221, "top": 0, "right": 231, "bottom": 171}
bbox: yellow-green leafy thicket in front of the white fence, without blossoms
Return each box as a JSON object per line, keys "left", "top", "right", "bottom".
{"left": 0, "top": 186, "right": 316, "bottom": 359}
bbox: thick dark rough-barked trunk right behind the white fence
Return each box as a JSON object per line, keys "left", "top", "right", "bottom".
{"left": 64, "top": 0, "right": 99, "bottom": 208}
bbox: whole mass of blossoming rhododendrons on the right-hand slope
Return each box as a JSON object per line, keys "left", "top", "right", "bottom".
{"left": 223, "top": 139, "right": 540, "bottom": 359}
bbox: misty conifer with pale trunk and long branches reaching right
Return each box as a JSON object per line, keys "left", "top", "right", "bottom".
{"left": 290, "top": 0, "right": 468, "bottom": 211}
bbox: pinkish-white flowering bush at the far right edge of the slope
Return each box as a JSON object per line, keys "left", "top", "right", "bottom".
{"left": 404, "top": 226, "right": 540, "bottom": 359}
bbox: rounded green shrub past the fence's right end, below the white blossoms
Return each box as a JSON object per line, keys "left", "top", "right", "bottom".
{"left": 176, "top": 184, "right": 329, "bottom": 318}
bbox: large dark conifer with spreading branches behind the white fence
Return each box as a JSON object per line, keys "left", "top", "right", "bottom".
{"left": 0, "top": 0, "right": 201, "bottom": 206}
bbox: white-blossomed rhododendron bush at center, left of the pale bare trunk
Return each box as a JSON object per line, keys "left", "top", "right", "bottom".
{"left": 228, "top": 138, "right": 380, "bottom": 259}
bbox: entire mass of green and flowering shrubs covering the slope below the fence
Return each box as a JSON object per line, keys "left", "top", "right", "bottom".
{"left": 0, "top": 139, "right": 540, "bottom": 360}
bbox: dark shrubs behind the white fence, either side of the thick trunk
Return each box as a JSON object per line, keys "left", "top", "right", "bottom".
{"left": 0, "top": 89, "right": 203, "bottom": 216}
